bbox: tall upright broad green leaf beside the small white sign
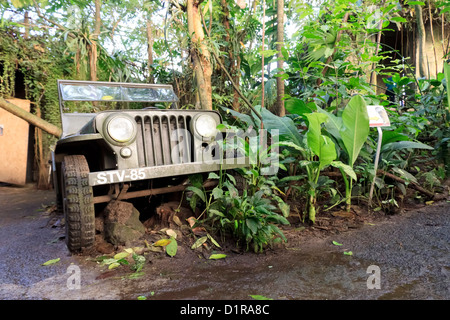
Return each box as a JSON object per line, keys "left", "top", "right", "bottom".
{"left": 340, "top": 96, "right": 370, "bottom": 167}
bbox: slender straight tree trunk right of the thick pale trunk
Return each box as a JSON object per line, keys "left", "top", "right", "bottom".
{"left": 277, "top": 0, "right": 286, "bottom": 117}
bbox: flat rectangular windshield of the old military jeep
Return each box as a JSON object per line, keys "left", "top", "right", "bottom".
{"left": 58, "top": 80, "right": 178, "bottom": 113}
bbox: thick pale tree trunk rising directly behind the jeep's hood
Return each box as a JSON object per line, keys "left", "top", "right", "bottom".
{"left": 186, "top": 0, "right": 212, "bottom": 110}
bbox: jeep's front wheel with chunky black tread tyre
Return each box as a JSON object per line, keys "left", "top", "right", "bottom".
{"left": 61, "top": 155, "right": 95, "bottom": 252}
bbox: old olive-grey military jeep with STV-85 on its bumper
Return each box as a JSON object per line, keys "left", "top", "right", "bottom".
{"left": 52, "top": 80, "right": 245, "bottom": 252}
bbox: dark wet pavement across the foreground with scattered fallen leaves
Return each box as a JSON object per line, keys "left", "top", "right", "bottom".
{"left": 0, "top": 186, "right": 450, "bottom": 300}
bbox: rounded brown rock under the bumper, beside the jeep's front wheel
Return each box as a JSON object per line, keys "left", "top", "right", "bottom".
{"left": 104, "top": 201, "right": 145, "bottom": 245}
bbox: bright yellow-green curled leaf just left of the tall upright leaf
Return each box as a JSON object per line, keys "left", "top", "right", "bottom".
{"left": 306, "top": 113, "right": 337, "bottom": 169}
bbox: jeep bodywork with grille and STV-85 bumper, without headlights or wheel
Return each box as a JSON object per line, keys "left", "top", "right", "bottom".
{"left": 52, "top": 80, "right": 248, "bottom": 203}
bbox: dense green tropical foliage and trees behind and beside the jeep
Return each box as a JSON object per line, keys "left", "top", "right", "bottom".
{"left": 0, "top": 0, "right": 450, "bottom": 251}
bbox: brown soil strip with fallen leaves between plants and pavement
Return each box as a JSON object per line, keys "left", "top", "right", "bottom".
{"left": 59, "top": 184, "right": 446, "bottom": 279}
